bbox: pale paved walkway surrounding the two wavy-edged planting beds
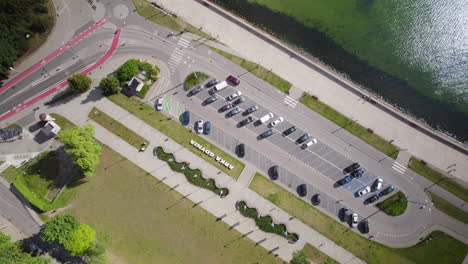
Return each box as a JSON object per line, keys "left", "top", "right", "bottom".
{"left": 50, "top": 92, "right": 363, "bottom": 263}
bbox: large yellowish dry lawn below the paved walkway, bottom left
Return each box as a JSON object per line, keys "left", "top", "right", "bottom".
{"left": 68, "top": 146, "right": 282, "bottom": 264}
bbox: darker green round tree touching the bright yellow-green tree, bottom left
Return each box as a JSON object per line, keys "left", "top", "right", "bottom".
{"left": 41, "top": 214, "right": 80, "bottom": 244}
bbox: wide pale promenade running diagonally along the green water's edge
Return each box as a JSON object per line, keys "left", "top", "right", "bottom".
{"left": 154, "top": 0, "right": 468, "bottom": 184}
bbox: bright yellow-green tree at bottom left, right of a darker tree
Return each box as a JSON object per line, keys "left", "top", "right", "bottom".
{"left": 63, "top": 223, "right": 96, "bottom": 256}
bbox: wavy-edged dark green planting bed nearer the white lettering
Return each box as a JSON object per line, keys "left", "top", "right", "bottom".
{"left": 153, "top": 147, "right": 229, "bottom": 197}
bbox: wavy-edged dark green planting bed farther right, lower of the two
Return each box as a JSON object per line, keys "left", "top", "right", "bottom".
{"left": 236, "top": 201, "right": 299, "bottom": 243}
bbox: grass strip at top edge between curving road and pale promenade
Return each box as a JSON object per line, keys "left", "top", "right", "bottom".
{"left": 132, "top": 0, "right": 211, "bottom": 39}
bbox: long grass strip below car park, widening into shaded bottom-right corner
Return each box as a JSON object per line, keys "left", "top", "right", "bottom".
{"left": 250, "top": 175, "right": 468, "bottom": 264}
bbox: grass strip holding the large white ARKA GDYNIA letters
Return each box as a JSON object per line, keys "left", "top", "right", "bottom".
{"left": 107, "top": 94, "right": 245, "bottom": 179}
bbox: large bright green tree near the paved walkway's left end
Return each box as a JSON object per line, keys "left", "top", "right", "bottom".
{"left": 59, "top": 124, "right": 102, "bottom": 176}
